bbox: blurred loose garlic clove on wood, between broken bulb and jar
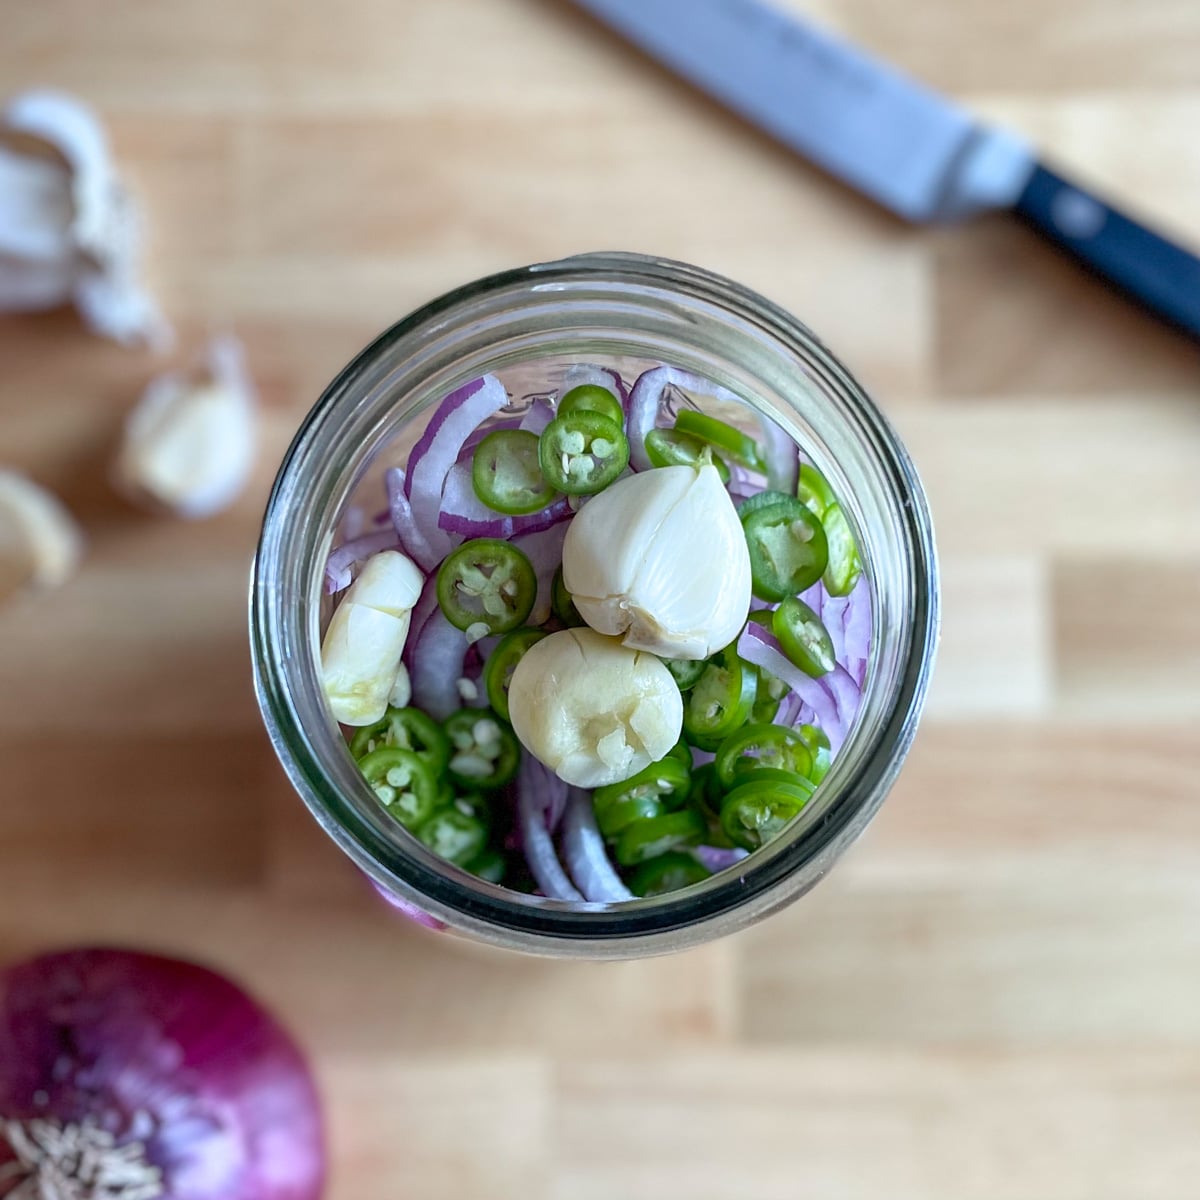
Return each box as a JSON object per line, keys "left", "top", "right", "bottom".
{"left": 113, "top": 337, "right": 258, "bottom": 518}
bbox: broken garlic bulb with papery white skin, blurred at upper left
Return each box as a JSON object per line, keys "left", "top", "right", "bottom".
{"left": 0, "top": 90, "right": 172, "bottom": 348}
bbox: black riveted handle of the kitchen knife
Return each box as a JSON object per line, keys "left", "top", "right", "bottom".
{"left": 1016, "top": 164, "right": 1200, "bottom": 338}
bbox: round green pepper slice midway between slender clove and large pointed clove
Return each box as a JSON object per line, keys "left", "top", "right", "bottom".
{"left": 437, "top": 538, "right": 538, "bottom": 634}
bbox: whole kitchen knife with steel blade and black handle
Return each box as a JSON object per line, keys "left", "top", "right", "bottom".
{"left": 575, "top": 0, "right": 1200, "bottom": 338}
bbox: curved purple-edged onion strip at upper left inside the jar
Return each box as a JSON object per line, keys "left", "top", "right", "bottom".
{"left": 400, "top": 376, "right": 509, "bottom": 558}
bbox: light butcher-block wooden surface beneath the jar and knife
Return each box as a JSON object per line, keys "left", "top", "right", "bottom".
{"left": 0, "top": 0, "right": 1200, "bottom": 1200}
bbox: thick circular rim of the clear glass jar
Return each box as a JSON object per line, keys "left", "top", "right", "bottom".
{"left": 251, "top": 253, "right": 940, "bottom": 956}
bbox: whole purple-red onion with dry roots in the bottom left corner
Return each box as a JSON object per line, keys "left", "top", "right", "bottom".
{"left": 0, "top": 949, "right": 325, "bottom": 1200}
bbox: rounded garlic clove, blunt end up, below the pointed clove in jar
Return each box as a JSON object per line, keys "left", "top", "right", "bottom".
{"left": 509, "top": 624, "right": 683, "bottom": 787}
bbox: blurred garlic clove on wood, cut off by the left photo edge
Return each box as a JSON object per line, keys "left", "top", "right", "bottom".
{"left": 0, "top": 469, "right": 83, "bottom": 598}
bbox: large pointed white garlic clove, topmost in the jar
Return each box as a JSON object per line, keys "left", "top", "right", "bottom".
{"left": 563, "top": 464, "right": 750, "bottom": 659}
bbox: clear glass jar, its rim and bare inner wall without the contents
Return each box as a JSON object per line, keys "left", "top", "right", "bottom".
{"left": 251, "top": 253, "right": 938, "bottom": 958}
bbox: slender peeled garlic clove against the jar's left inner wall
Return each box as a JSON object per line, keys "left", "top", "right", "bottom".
{"left": 320, "top": 550, "right": 427, "bottom": 726}
